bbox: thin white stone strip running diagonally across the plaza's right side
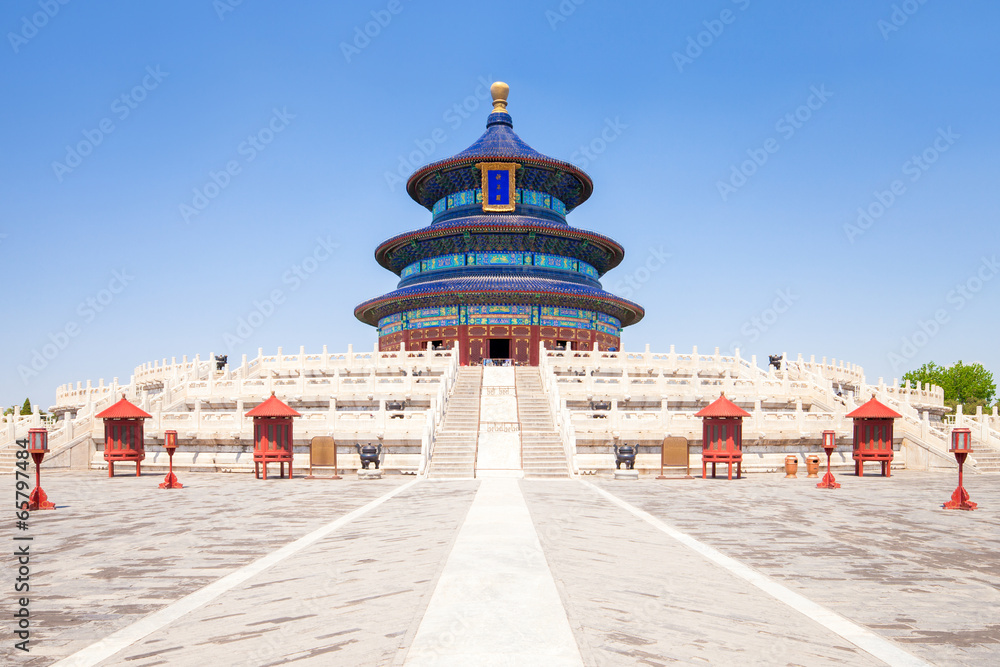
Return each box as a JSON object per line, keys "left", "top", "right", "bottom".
{"left": 580, "top": 480, "right": 933, "bottom": 667}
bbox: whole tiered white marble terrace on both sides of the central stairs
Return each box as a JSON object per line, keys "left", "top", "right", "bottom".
{"left": 0, "top": 346, "right": 1000, "bottom": 474}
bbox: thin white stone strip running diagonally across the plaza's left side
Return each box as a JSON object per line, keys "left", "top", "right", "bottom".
{"left": 52, "top": 479, "right": 420, "bottom": 667}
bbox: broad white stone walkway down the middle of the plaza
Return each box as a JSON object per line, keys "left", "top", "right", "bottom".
{"left": 404, "top": 479, "right": 583, "bottom": 667}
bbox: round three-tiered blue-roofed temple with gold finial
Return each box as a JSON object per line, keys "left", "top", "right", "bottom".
{"left": 354, "top": 82, "right": 644, "bottom": 366}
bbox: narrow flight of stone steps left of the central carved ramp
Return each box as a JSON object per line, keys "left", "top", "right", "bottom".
{"left": 427, "top": 366, "right": 483, "bottom": 479}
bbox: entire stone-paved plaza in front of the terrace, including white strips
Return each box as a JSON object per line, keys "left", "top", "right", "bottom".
{"left": 9, "top": 471, "right": 1000, "bottom": 667}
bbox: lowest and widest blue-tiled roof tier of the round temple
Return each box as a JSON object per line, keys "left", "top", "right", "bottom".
{"left": 354, "top": 272, "right": 645, "bottom": 326}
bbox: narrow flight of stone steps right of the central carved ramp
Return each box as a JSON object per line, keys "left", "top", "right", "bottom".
{"left": 514, "top": 368, "right": 569, "bottom": 479}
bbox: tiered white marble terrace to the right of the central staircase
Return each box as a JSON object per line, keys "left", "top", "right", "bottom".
{"left": 541, "top": 346, "right": 1000, "bottom": 474}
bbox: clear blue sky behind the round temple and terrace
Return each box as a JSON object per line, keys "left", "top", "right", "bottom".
{"left": 0, "top": 0, "right": 1000, "bottom": 407}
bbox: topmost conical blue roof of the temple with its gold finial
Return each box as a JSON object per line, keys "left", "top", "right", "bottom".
{"left": 406, "top": 81, "right": 594, "bottom": 211}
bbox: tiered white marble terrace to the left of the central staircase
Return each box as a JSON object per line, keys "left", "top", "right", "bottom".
{"left": 0, "top": 348, "right": 458, "bottom": 474}
